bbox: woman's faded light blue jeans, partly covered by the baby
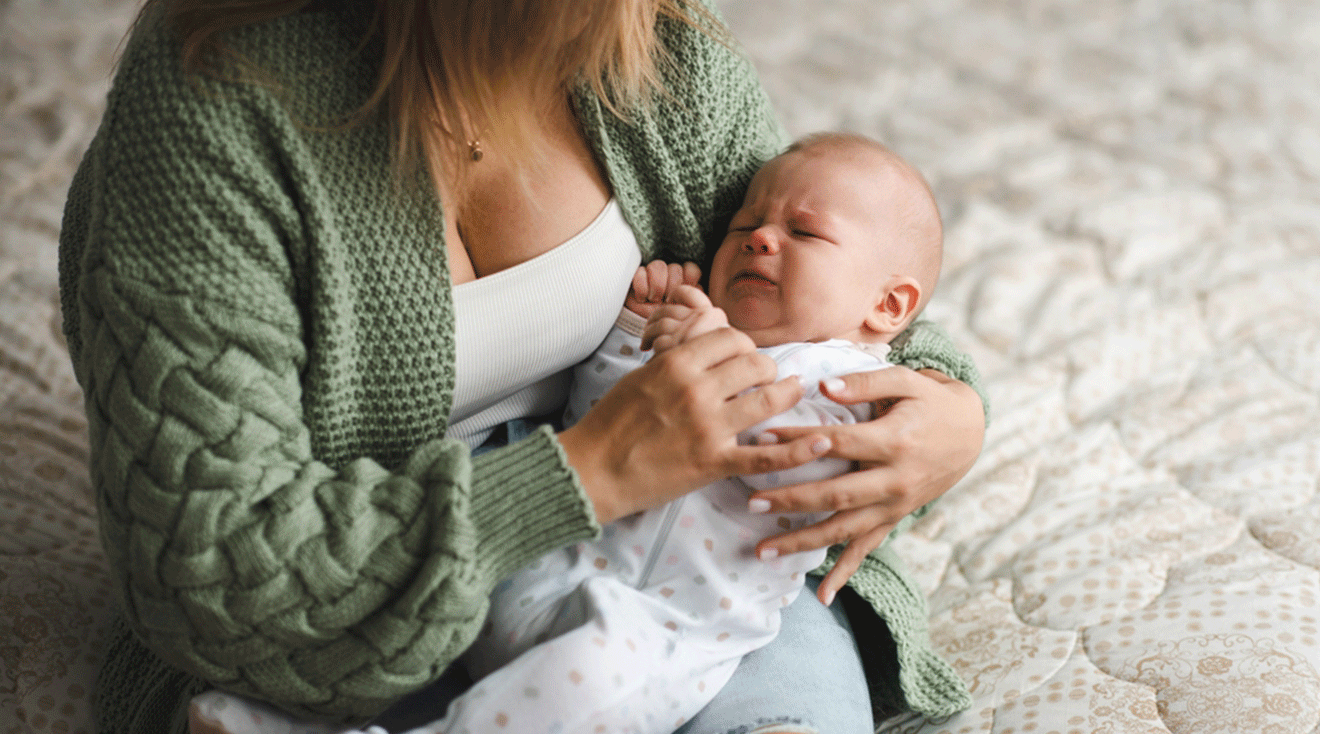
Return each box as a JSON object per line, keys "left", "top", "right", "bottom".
{"left": 375, "top": 421, "right": 875, "bottom": 734}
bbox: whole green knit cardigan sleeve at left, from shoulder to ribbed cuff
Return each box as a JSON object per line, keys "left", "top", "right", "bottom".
{"left": 61, "top": 11, "right": 598, "bottom": 729}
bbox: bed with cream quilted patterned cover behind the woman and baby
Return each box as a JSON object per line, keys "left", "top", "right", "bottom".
{"left": 0, "top": 0, "right": 1320, "bottom": 734}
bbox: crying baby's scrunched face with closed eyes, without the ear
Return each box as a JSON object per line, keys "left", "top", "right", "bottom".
{"left": 710, "top": 150, "right": 899, "bottom": 347}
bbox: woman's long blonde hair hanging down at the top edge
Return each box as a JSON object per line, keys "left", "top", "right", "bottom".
{"left": 153, "top": 0, "right": 729, "bottom": 192}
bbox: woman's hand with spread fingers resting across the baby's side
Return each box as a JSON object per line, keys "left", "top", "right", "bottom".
{"left": 750, "top": 367, "right": 985, "bottom": 603}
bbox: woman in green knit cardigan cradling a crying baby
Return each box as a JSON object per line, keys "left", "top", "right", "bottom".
{"left": 61, "top": 0, "right": 983, "bottom": 731}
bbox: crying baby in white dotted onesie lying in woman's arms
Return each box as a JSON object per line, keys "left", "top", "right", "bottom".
{"left": 191, "top": 133, "right": 942, "bottom": 734}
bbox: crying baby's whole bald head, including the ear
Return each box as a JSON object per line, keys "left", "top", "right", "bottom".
{"left": 709, "top": 133, "right": 942, "bottom": 346}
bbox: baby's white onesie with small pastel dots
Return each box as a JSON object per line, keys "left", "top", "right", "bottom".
{"left": 438, "top": 312, "right": 888, "bottom": 734}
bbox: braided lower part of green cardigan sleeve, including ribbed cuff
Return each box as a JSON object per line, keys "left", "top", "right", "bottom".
{"left": 79, "top": 269, "right": 597, "bottom": 722}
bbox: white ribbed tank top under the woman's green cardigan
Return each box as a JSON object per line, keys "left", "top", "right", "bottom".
{"left": 446, "top": 199, "right": 642, "bottom": 448}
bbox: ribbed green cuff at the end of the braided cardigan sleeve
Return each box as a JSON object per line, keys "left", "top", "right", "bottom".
{"left": 471, "top": 425, "right": 601, "bottom": 580}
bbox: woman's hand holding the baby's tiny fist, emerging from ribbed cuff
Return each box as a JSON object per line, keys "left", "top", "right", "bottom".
{"left": 560, "top": 327, "right": 829, "bottom": 523}
